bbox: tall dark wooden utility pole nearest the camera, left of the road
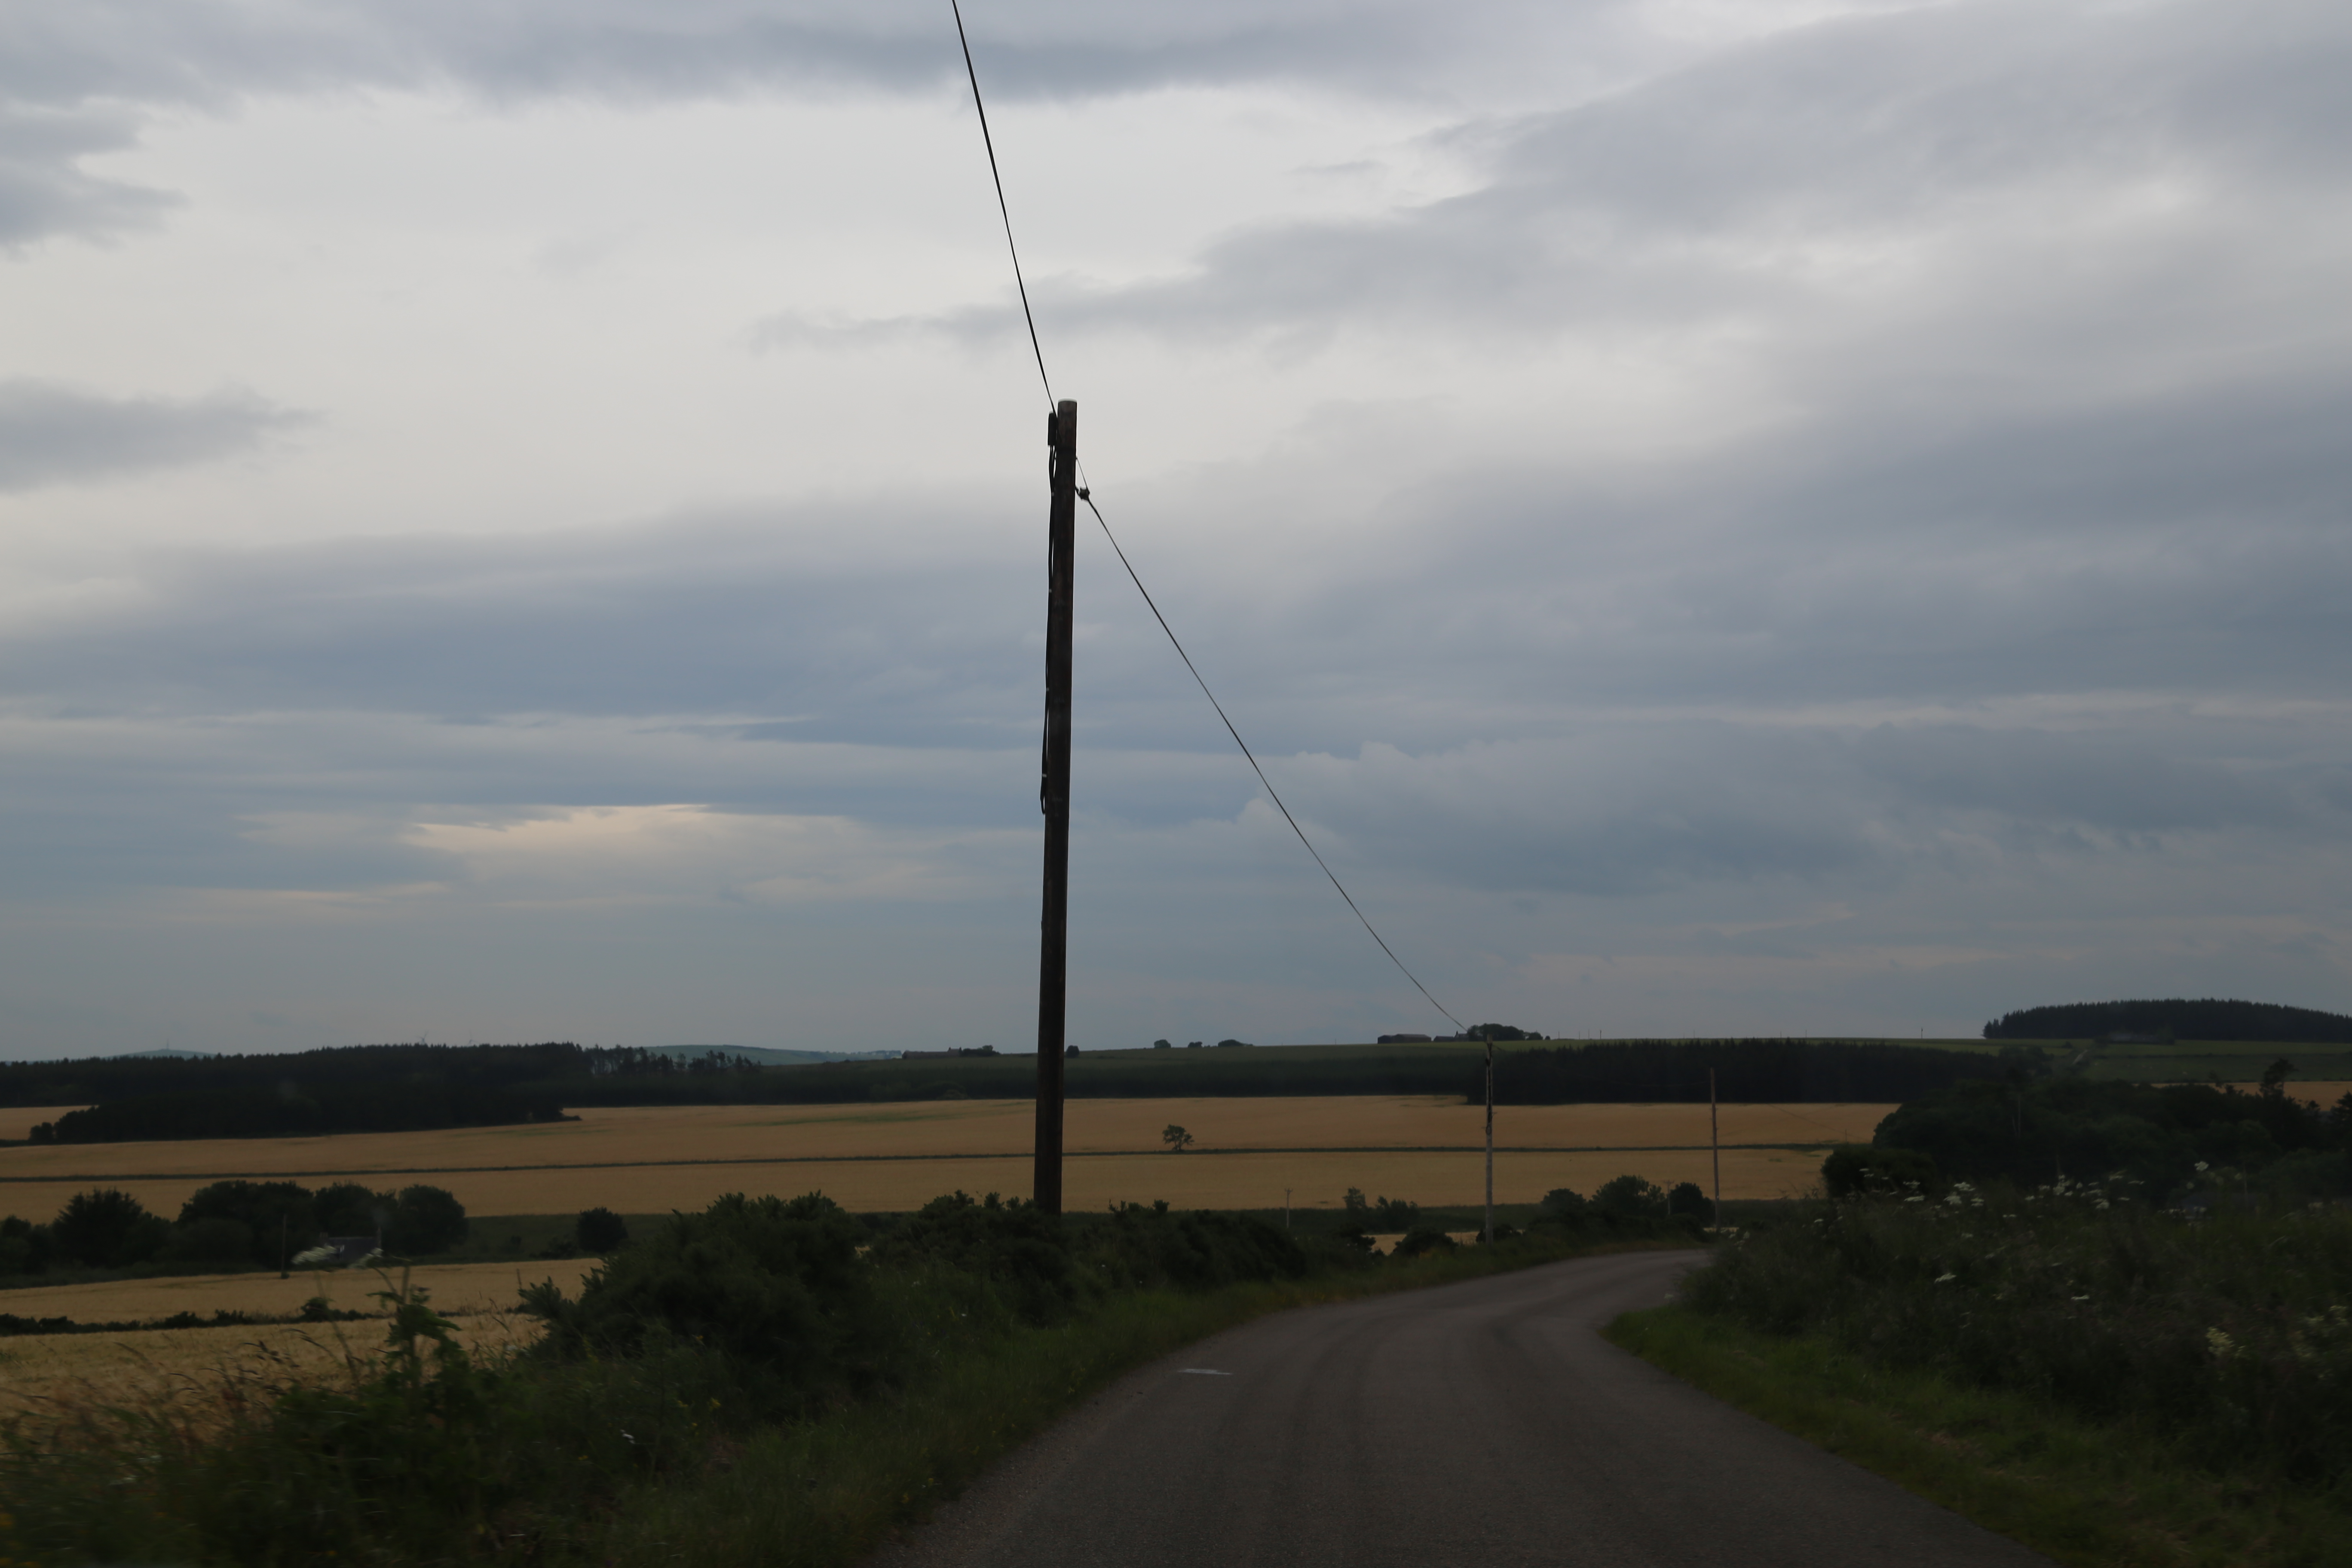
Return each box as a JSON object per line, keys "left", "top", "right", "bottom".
{"left": 1030, "top": 400, "right": 1077, "bottom": 1213}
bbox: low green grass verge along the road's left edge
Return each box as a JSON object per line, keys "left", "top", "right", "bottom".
{"left": 579, "top": 1241, "right": 1681, "bottom": 1568}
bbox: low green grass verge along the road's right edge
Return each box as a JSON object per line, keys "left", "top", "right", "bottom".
{"left": 1604, "top": 1307, "right": 2352, "bottom": 1568}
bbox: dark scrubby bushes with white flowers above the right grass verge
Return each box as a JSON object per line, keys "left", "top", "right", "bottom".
{"left": 1684, "top": 1178, "right": 2352, "bottom": 1486}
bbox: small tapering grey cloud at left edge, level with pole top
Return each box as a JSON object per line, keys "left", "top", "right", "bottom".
{"left": 0, "top": 379, "right": 301, "bottom": 491}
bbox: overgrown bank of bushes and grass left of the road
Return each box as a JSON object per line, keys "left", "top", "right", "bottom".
{"left": 0, "top": 1194, "right": 1689, "bottom": 1568}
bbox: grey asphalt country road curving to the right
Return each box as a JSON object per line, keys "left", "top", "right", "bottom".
{"left": 875, "top": 1253, "right": 2049, "bottom": 1568}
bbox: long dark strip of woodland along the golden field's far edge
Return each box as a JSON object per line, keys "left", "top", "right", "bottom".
{"left": 0, "top": 1039, "right": 2004, "bottom": 1142}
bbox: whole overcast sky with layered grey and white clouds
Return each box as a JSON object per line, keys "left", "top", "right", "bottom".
{"left": 0, "top": 0, "right": 2352, "bottom": 1058}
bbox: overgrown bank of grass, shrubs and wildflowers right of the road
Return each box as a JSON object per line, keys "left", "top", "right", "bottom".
{"left": 1609, "top": 1178, "right": 2352, "bottom": 1568}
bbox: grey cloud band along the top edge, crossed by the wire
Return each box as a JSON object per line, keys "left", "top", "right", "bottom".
{"left": 0, "top": 0, "right": 1642, "bottom": 101}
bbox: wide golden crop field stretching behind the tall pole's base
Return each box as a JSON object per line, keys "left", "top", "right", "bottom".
{"left": 0, "top": 1096, "right": 1893, "bottom": 1222}
